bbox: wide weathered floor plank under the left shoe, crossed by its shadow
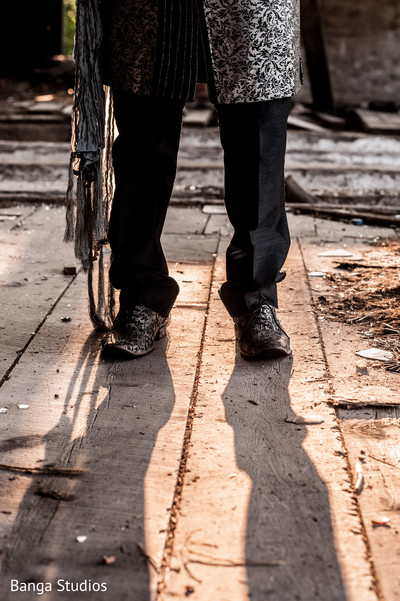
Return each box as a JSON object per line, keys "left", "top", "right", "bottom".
{"left": 0, "top": 258, "right": 216, "bottom": 601}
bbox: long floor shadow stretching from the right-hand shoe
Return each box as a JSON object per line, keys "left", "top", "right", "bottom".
{"left": 223, "top": 357, "right": 347, "bottom": 601}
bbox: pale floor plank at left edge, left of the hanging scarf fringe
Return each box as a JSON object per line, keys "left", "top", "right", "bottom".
{"left": 0, "top": 207, "right": 77, "bottom": 379}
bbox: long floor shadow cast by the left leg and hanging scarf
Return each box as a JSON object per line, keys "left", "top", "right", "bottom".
{"left": 1, "top": 334, "right": 175, "bottom": 601}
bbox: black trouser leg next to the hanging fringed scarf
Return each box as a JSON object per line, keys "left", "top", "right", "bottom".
{"left": 109, "top": 92, "right": 183, "bottom": 316}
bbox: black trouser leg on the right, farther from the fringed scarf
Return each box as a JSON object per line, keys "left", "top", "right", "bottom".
{"left": 217, "top": 98, "right": 291, "bottom": 317}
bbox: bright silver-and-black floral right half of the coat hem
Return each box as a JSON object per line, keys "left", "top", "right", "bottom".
{"left": 204, "top": 0, "right": 301, "bottom": 104}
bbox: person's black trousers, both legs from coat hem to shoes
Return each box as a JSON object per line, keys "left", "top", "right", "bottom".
{"left": 109, "top": 92, "right": 291, "bottom": 317}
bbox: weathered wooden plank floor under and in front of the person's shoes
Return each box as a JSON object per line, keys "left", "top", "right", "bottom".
{"left": 0, "top": 207, "right": 400, "bottom": 601}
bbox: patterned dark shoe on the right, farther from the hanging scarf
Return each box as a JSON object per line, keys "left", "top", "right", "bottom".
{"left": 233, "top": 303, "right": 292, "bottom": 359}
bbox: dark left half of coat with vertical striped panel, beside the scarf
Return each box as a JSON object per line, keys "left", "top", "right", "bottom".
{"left": 101, "top": 0, "right": 199, "bottom": 100}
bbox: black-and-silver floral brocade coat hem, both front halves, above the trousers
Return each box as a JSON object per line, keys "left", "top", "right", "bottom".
{"left": 100, "top": 0, "right": 301, "bottom": 104}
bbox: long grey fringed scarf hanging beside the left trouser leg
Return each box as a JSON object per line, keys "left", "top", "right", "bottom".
{"left": 64, "top": 0, "right": 114, "bottom": 331}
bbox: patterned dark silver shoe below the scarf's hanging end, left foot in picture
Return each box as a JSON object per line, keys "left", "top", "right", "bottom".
{"left": 101, "top": 305, "right": 168, "bottom": 359}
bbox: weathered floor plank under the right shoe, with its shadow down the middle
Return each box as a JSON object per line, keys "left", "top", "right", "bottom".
{"left": 162, "top": 237, "right": 377, "bottom": 601}
